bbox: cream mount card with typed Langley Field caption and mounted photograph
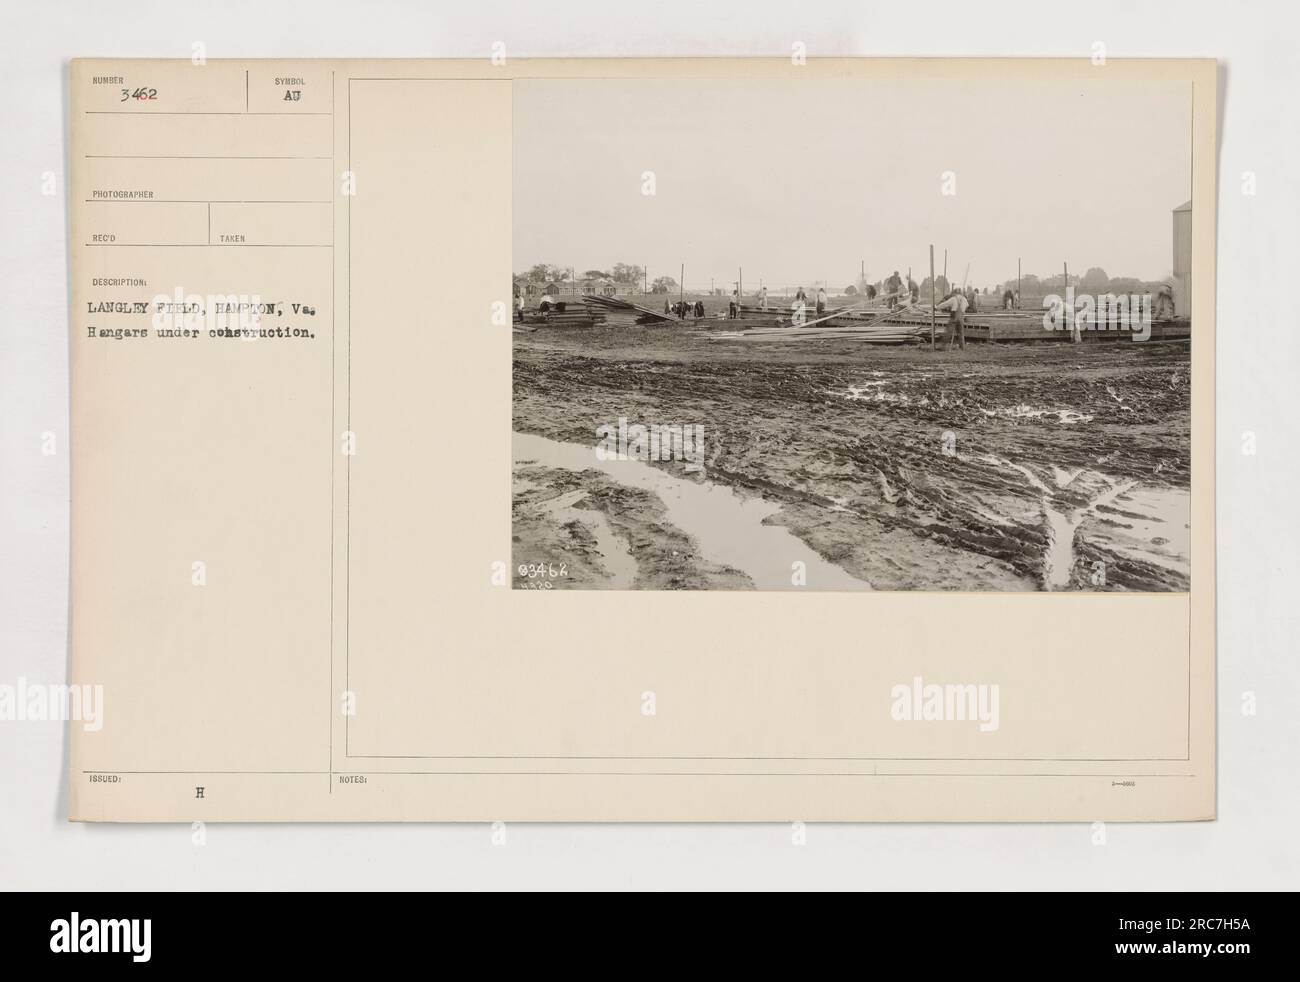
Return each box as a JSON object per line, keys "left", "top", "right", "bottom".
{"left": 69, "top": 59, "right": 1217, "bottom": 821}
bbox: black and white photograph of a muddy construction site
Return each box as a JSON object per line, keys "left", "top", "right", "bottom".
{"left": 512, "top": 78, "right": 1195, "bottom": 592}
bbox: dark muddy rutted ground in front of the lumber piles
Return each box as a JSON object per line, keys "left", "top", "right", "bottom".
{"left": 514, "top": 326, "right": 1191, "bottom": 591}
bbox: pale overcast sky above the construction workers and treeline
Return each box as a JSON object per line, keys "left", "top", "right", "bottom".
{"left": 514, "top": 70, "right": 1191, "bottom": 291}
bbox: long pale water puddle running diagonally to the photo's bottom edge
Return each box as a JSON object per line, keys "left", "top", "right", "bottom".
{"left": 512, "top": 433, "right": 871, "bottom": 591}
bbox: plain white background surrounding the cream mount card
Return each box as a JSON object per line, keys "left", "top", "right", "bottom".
{"left": 0, "top": 0, "right": 1300, "bottom": 890}
